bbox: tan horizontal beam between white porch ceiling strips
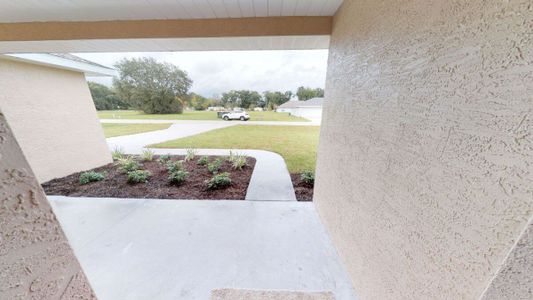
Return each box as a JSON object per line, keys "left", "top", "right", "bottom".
{"left": 0, "top": 17, "right": 332, "bottom": 41}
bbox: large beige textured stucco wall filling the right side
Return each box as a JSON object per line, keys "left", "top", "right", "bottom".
{"left": 315, "top": 0, "right": 533, "bottom": 299}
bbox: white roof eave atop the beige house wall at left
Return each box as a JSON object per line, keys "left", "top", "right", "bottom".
{"left": 0, "top": 53, "right": 117, "bottom": 76}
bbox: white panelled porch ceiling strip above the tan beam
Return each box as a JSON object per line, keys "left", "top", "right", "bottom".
{"left": 0, "top": 0, "right": 342, "bottom": 23}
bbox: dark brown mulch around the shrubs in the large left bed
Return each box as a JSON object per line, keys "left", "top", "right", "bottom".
{"left": 42, "top": 156, "right": 255, "bottom": 200}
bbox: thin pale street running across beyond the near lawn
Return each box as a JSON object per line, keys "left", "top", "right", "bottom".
{"left": 100, "top": 119, "right": 320, "bottom": 126}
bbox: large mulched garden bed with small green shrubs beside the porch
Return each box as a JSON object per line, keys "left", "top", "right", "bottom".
{"left": 42, "top": 150, "right": 255, "bottom": 200}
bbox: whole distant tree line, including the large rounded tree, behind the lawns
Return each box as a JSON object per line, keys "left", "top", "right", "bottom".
{"left": 89, "top": 58, "right": 324, "bottom": 114}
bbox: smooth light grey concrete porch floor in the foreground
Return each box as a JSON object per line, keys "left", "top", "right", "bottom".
{"left": 48, "top": 196, "right": 356, "bottom": 300}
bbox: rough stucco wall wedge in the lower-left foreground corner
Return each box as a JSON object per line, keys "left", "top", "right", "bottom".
{"left": 0, "top": 113, "right": 95, "bottom": 300}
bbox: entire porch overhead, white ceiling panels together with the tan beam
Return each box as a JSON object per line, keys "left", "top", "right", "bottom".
{"left": 0, "top": 0, "right": 336, "bottom": 53}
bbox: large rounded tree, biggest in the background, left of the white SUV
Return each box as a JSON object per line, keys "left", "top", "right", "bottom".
{"left": 113, "top": 57, "right": 192, "bottom": 114}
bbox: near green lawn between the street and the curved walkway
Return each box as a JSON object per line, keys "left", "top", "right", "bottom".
{"left": 150, "top": 125, "right": 320, "bottom": 173}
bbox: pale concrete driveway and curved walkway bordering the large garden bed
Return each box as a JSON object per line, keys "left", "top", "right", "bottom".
{"left": 107, "top": 122, "right": 296, "bottom": 201}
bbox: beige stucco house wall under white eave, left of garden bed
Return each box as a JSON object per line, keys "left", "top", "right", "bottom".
{"left": 0, "top": 59, "right": 111, "bottom": 182}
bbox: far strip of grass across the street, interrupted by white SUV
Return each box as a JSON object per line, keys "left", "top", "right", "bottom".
{"left": 98, "top": 110, "right": 309, "bottom": 122}
